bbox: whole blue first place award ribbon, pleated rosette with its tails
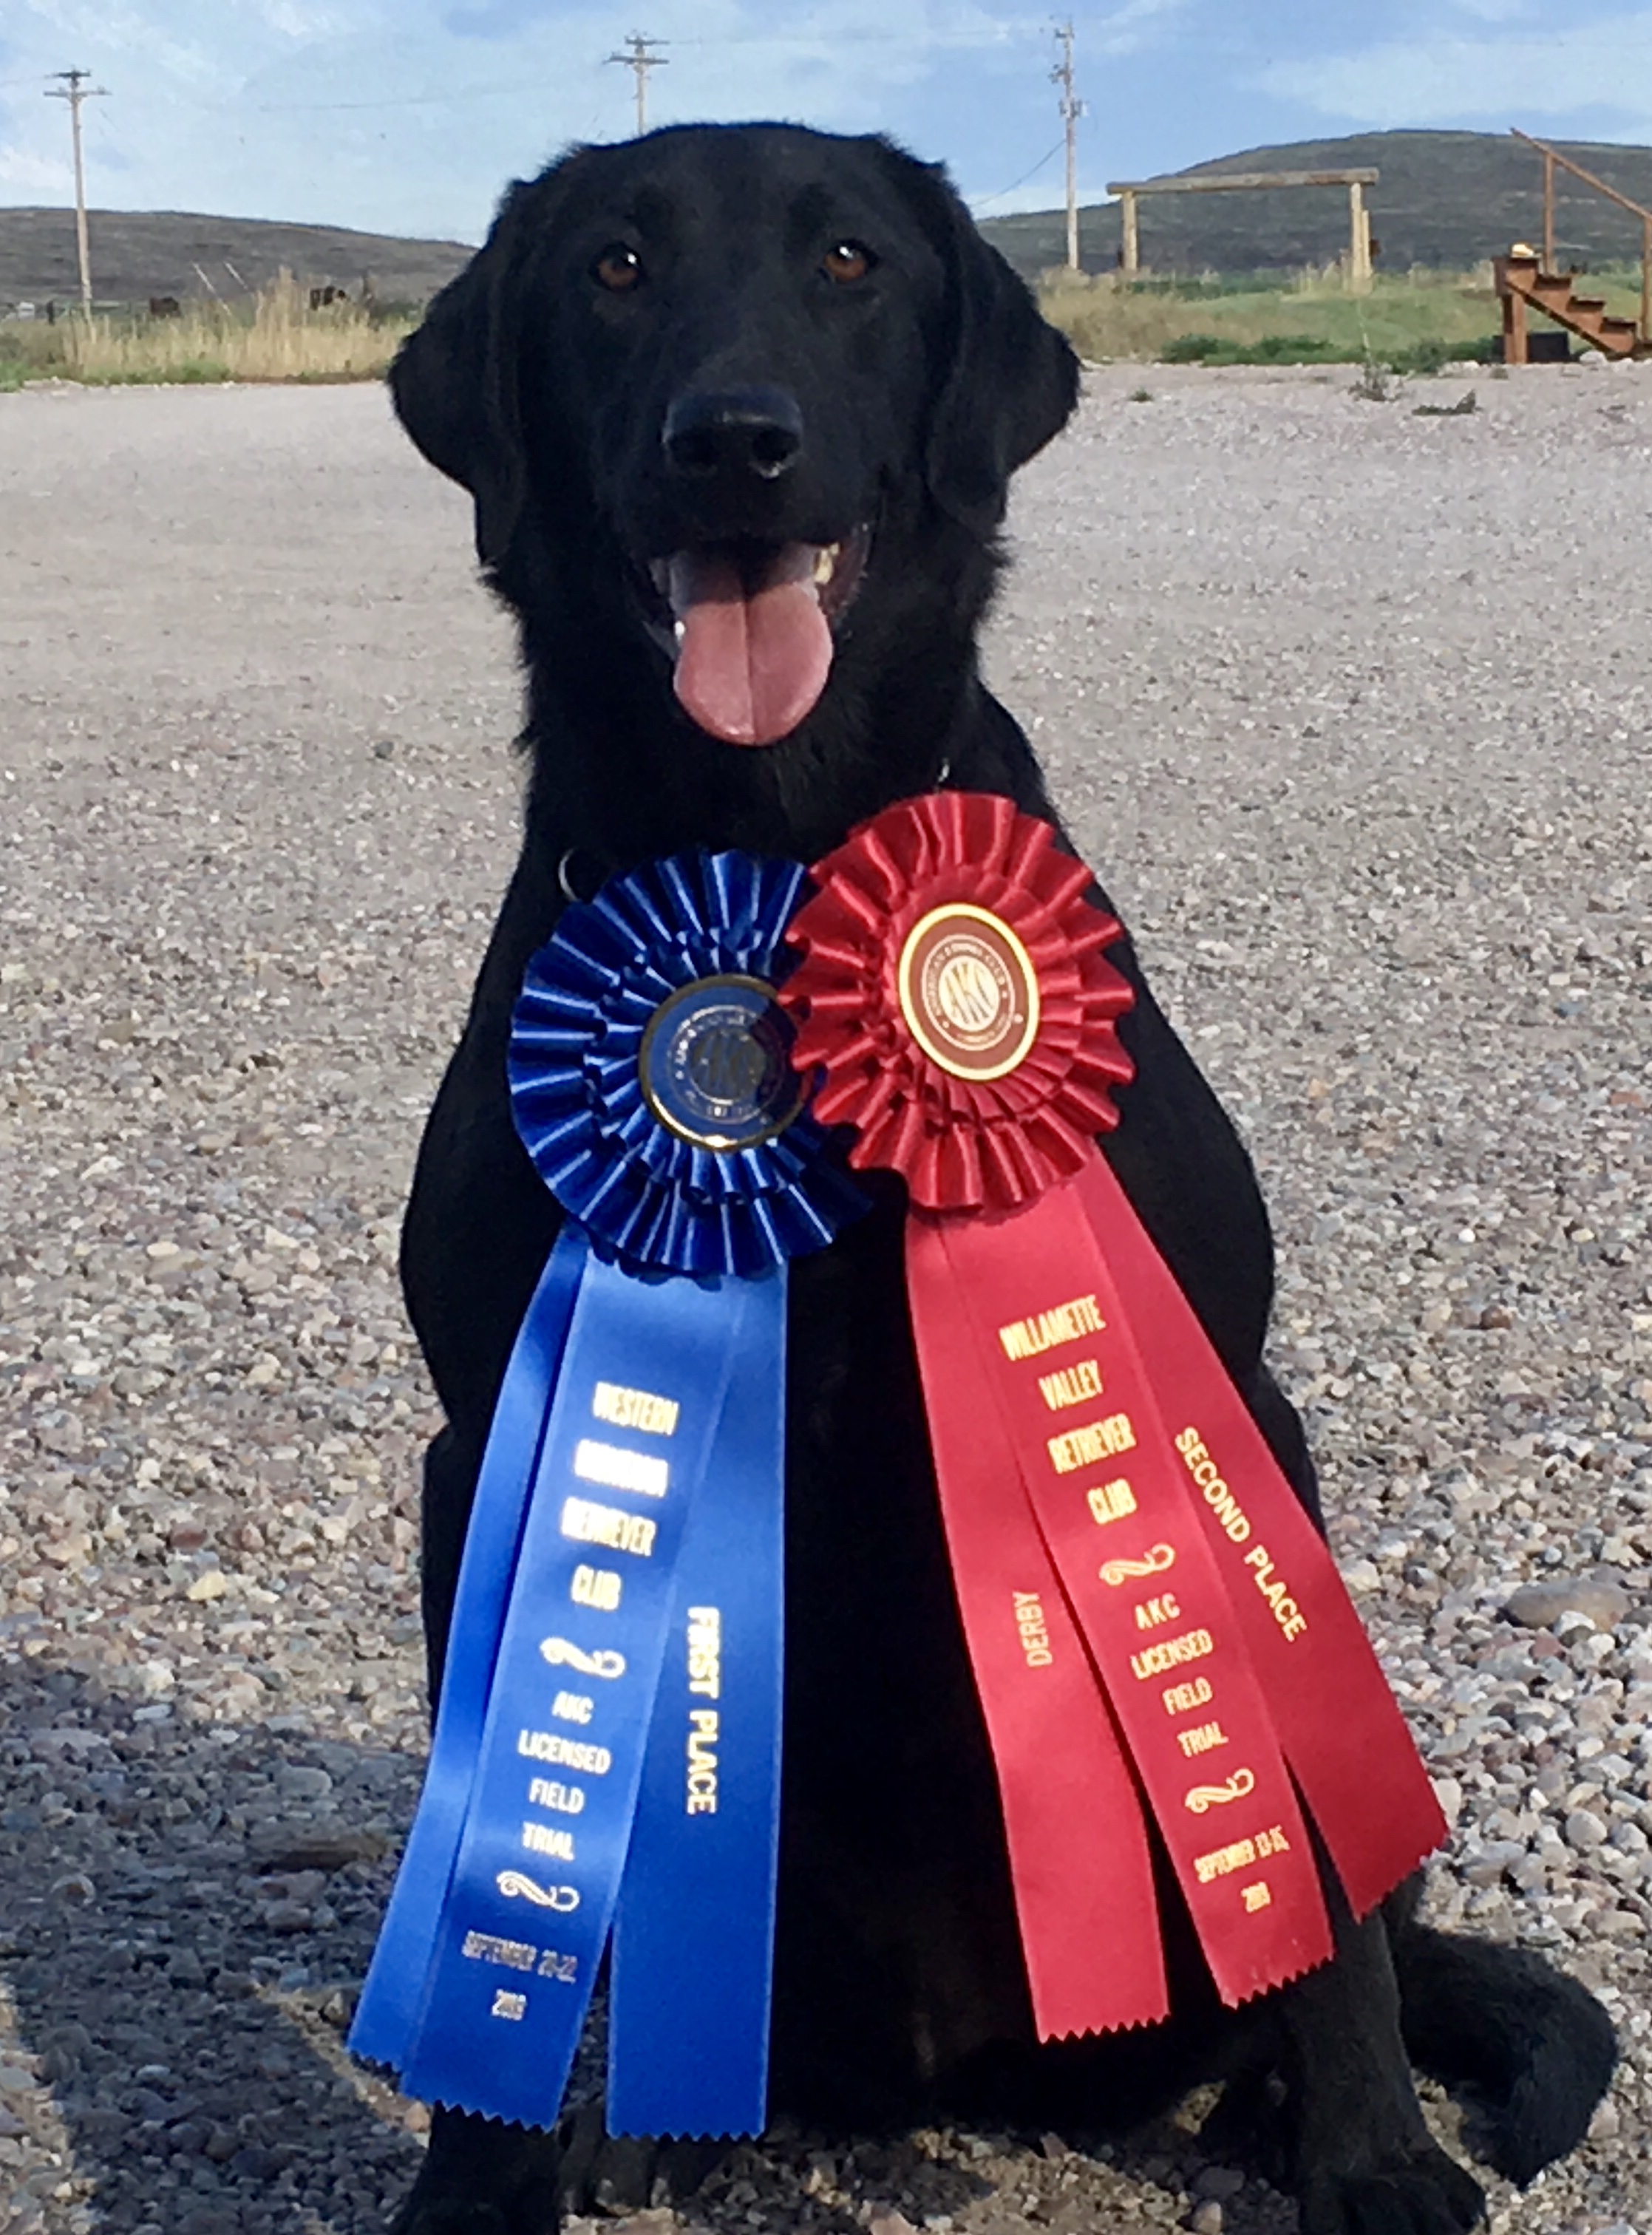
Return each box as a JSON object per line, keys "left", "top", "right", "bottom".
{"left": 351, "top": 854, "right": 863, "bottom": 2134}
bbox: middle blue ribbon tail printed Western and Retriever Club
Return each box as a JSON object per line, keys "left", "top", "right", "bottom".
{"left": 378, "top": 1253, "right": 760, "bottom": 2126}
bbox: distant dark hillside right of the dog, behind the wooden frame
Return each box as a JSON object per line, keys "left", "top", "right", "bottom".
{"left": 982, "top": 132, "right": 1652, "bottom": 277}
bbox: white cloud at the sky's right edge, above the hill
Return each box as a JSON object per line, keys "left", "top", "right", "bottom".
{"left": 1257, "top": 9, "right": 1652, "bottom": 127}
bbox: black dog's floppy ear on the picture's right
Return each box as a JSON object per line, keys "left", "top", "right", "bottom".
{"left": 914, "top": 166, "right": 1078, "bottom": 534}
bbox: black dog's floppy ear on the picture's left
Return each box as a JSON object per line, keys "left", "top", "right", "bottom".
{"left": 389, "top": 181, "right": 543, "bottom": 572}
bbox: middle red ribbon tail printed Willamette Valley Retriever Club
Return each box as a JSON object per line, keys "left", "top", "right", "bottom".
{"left": 941, "top": 1187, "right": 1333, "bottom": 2005}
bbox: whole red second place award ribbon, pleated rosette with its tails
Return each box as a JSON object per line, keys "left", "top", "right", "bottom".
{"left": 781, "top": 791, "right": 1444, "bottom": 2038}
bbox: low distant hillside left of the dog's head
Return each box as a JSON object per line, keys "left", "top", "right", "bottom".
{"left": 0, "top": 208, "right": 472, "bottom": 304}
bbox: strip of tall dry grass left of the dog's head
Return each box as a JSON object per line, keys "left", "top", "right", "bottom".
{"left": 0, "top": 275, "right": 416, "bottom": 387}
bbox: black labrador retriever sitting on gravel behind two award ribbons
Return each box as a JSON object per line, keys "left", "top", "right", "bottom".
{"left": 375, "top": 125, "right": 1614, "bottom": 2235}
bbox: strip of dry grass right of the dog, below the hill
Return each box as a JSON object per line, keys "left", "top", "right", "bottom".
{"left": 1041, "top": 266, "right": 1641, "bottom": 367}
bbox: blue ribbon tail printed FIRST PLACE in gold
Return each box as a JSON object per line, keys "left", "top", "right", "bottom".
{"left": 608, "top": 1265, "right": 787, "bottom": 2134}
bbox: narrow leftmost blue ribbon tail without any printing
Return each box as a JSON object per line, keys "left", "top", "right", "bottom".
{"left": 349, "top": 1222, "right": 585, "bottom": 2072}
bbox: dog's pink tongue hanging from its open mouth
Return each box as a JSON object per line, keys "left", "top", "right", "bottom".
{"left": 670, "top": 543, "right": 832, "bottom": 744}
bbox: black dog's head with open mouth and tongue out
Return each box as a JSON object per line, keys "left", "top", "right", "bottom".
{"left": 391, "top": 125, "right": 1078, "bottom": 764}
